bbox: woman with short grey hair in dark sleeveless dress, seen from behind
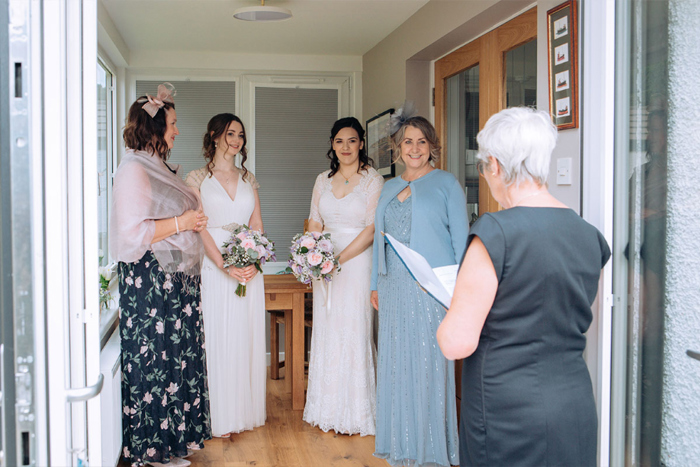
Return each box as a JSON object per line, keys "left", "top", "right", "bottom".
{"left": 437, "top": 108, "right": 610, "bottom": 467}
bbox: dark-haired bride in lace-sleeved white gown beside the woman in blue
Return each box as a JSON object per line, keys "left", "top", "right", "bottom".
{"left": 304, "top": 117, "right": 384, "bottom": 436}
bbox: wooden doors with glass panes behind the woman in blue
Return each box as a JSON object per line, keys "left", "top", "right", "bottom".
{"left": 435, "top": 7, "right": 537, "bottom": 219}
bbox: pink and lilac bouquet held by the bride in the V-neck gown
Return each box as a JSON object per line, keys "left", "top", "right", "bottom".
{"left": 222, "top": 225, "right": 275, "bottom": 297}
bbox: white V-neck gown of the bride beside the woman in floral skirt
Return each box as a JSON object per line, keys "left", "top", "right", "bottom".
{"left": 200, "top": 170, "right": 267, "bottom": 436}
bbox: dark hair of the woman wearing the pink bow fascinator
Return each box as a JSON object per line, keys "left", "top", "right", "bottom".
{"left": 123, "top": 96, "right": 175, "bottom": 161}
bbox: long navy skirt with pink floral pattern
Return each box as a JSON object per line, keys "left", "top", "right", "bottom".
{"left": 119, "top": 251, "right": 211, "bottom": 466}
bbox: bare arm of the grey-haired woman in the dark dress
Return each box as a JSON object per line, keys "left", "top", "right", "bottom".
{"left": 437, "top": 237, "right": 498, "bottom": 360}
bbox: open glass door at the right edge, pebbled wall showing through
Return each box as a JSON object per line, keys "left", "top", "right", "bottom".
{"left": 610, "top": 0, "right": 700, "bottom": 466}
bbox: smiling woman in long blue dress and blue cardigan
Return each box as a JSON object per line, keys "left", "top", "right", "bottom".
{"left": 371, "top": 110, "right": 469, "bottom": 466}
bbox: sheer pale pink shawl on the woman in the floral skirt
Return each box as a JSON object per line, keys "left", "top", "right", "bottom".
{"left": 109, "top": 149, "right": 204, "bottom": 275}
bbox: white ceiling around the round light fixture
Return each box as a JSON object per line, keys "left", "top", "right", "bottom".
{"left": 100, "top": 0, "right": 428, "bottom": 55}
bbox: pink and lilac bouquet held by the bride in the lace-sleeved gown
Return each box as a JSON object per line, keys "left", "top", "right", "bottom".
{"left": 286, "top": 232, "right": 340, "bottom": 284}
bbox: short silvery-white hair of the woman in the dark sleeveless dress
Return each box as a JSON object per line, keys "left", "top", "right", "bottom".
{"left": 476, "top": 107, "right": 557, "bottom": 186}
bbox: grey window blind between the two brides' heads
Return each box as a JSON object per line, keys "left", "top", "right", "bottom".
{"left": 255, "top": 87, "right": 338, "bottom": 252}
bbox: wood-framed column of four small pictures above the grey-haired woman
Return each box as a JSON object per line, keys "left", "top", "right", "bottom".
{"left": 547, "top": 0, "right": 578, "bottom": 130}
